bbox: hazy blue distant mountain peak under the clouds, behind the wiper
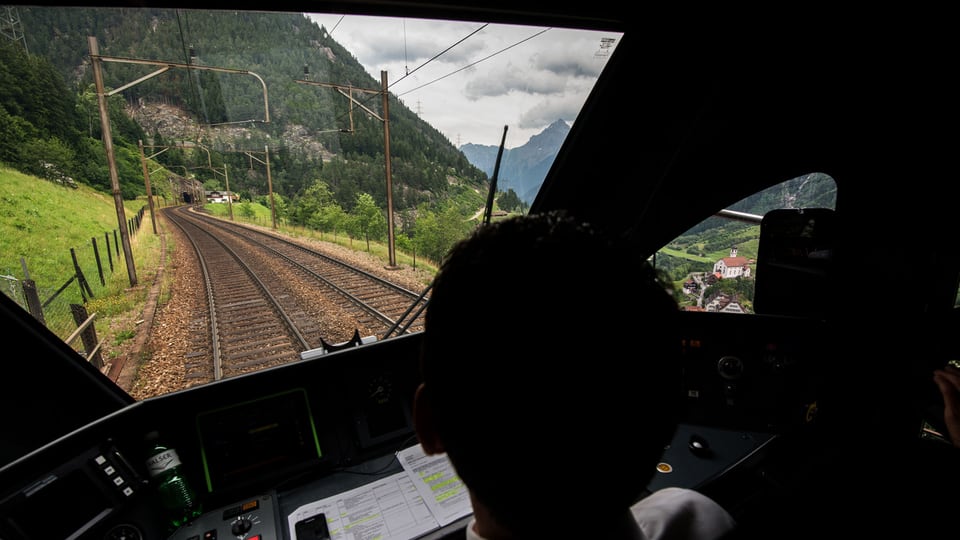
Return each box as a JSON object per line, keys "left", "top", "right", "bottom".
{"left": 460, "top": 120, "right": 570, "bottom": 204}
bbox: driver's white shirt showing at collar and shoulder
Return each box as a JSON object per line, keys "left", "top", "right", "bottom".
{"left": 466, "top": 487, "right": 736, "bottom": 540}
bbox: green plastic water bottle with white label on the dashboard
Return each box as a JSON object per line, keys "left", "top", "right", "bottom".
{"left": 146, "top": 431, "right": 203, "bottom": 529}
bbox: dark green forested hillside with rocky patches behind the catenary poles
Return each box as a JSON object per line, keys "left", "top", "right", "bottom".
{"left": 0, "top": 6, "right": 496, "bottom": 257}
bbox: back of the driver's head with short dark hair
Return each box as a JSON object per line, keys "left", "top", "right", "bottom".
{"left": 421, "top": 212, "right": 681, "bottom": 533}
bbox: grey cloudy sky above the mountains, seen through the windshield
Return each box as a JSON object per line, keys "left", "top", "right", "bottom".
{"left": 310, "top": 14, "right": 620, "bottom": 148}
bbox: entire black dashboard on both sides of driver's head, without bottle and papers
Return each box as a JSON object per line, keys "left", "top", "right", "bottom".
{"left": 0, "top": 313, "right": 825, "bottom": 540}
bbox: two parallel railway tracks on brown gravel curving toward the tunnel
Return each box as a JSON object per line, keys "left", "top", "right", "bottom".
{"left": 163, "top": 206, "right": 426, "bottom": 384}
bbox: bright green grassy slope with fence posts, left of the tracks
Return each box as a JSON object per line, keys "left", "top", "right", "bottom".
{"left": 0, "top": 166, "right": 161, "bottom": 352}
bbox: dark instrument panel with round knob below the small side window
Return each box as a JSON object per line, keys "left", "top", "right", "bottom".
{"left": 680, "top": 312, "right": 831, "bottom": 432}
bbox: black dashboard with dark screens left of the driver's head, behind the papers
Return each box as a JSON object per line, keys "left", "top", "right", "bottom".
{"left": 0, "top": 335, "right": 419, "bottom": 540}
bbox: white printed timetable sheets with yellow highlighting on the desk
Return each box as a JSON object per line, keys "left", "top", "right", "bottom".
{"left": 287, "top": 444, "right": 473, "bottom": 540}
